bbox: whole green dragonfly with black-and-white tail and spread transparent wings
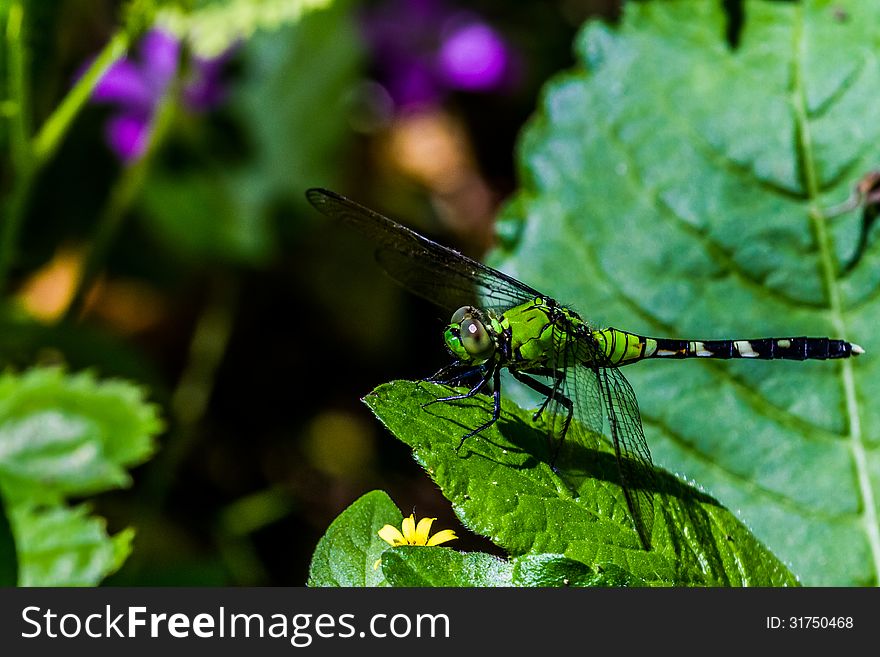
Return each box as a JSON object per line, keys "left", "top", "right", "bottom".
{"left": 306, "top": 188, "right": 864, "bottom": 550}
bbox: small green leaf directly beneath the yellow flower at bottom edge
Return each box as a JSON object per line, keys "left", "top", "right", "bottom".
{"left": 382, "top": 545, "right": 512, "bottom": 587}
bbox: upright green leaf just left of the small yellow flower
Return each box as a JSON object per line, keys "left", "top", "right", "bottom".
{"left": 308, "top": 490, "right": 403, "bottom": 586}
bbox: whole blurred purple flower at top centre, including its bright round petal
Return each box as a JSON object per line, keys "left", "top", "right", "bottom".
{"left": 362, "top": 0, "right": 512, "bottom": 109}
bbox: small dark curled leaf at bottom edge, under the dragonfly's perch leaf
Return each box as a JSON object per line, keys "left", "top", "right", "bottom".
{"left": 513, "top": 554, "right": 645, "bottom": 587}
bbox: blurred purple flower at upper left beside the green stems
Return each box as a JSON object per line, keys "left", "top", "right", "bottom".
{"left": 92, "top": 29, "right": 227, "bottom": 163}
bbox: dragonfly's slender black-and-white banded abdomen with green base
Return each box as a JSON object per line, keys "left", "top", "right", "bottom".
{"left": 593, "top": 328, "right": 864, "bottom": 365}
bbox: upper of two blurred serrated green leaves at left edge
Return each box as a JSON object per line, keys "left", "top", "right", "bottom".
{"left": 0, "top": 369, "right": 162, "bottom": 506}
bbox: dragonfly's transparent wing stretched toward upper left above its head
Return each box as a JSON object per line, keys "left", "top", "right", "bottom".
{"left": 306, "top": 188, "right": 541, "bottom": 311}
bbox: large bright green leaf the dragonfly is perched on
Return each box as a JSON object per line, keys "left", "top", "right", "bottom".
{"left": 364, "top": 381, "right": 796, "bottom": 586}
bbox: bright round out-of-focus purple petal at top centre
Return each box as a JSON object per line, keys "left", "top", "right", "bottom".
{"left": 438, "top": 23, "right": 508, "bottom": 90}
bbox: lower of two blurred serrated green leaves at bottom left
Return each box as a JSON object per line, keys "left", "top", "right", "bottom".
{"left": 12, "top": 506, "right": 134, "bottom": 586}
